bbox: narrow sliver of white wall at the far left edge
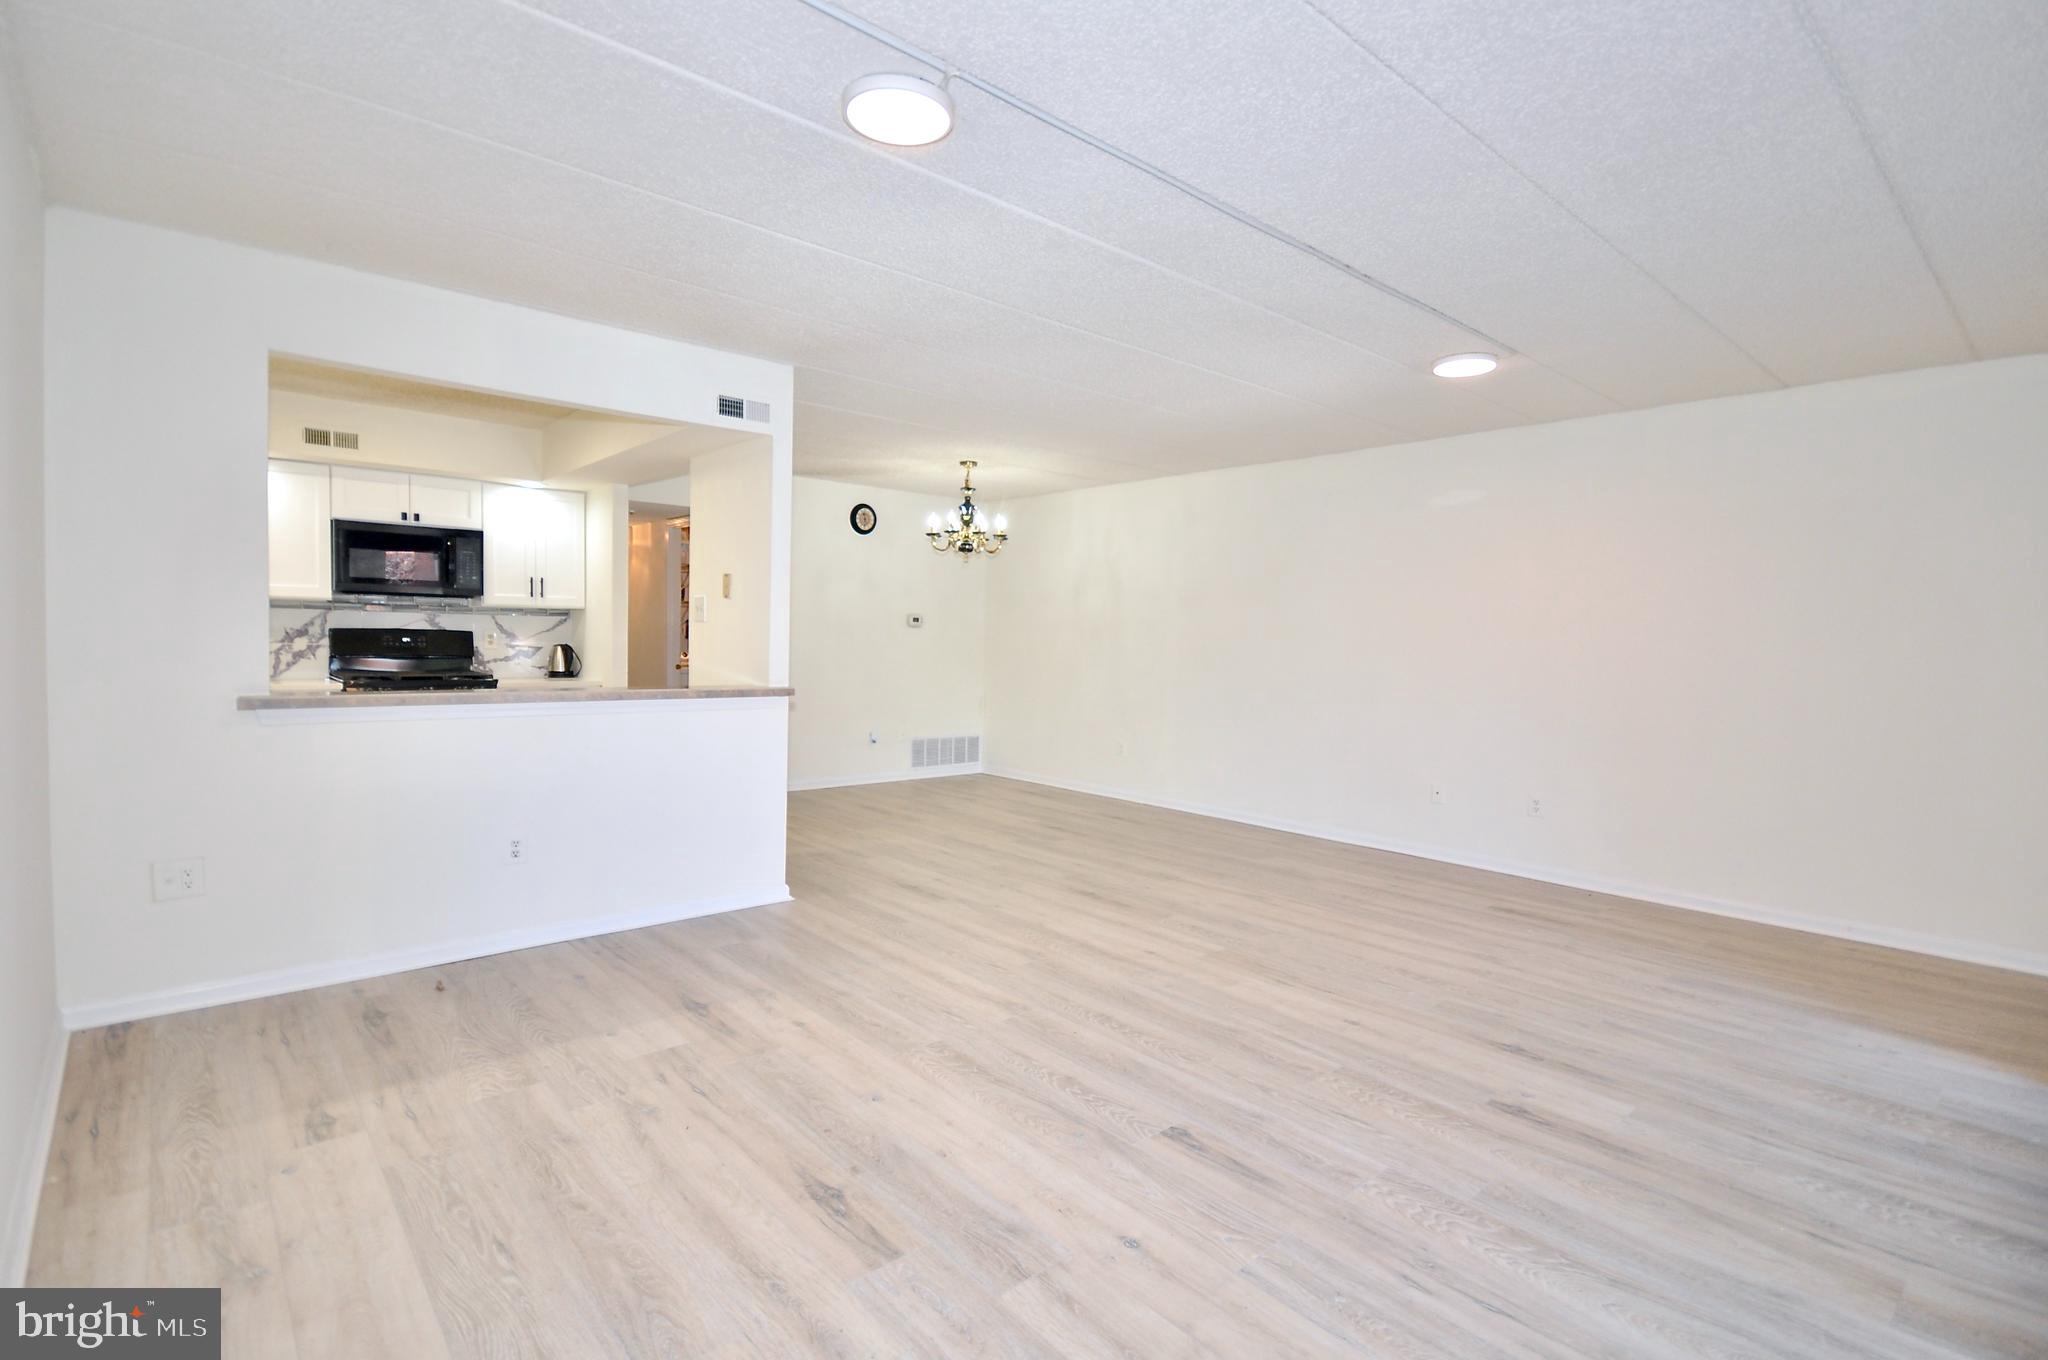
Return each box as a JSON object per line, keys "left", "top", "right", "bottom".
{"left": 0, "top": 45, "right": 63, "bottom": 1286}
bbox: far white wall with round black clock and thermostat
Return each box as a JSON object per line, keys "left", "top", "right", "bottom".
{"left": 786, "top": 477, "right": 987, "bottom": 789}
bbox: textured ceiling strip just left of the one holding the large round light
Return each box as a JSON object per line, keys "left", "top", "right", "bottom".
{"left": 19, "top": 0, "right": 1441, "bottom": 426}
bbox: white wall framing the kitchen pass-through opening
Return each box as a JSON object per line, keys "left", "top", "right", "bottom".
{"left": 45, "top": 211, "right": 791, "bottom": 1022}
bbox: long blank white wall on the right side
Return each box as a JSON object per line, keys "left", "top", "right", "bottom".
{"left": 987, "top": 356, "right": 2048, "bottom": 971}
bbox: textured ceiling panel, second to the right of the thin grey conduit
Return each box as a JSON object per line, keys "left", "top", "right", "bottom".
{"left": 1319, "top": 0, "right": 1968, "bottom": 383}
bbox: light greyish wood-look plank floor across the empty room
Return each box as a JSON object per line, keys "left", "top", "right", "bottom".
{"left": 31, "top": 776, "right": 2048, "bottom": 1360}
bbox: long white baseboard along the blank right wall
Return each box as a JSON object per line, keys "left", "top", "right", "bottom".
{"left": 987, "top": 766, "right": 2048, "bottom": 977}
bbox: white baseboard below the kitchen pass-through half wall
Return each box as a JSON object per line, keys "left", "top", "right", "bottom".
{"left": 63, "top": 883, "right": 788, "bottom": 1030}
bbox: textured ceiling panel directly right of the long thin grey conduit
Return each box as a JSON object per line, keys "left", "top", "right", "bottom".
{"left": 839, "top": 0, "right": 1772, "bottom": 406}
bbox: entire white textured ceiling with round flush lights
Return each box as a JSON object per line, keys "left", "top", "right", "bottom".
{"left": 0, "top": 0, "right": 2048, "bottom": 496}
